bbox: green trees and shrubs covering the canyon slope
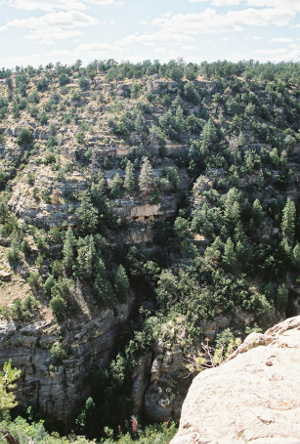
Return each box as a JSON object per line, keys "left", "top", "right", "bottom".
{"left": 0, "top": 60, "right": 300, "bottom": 442}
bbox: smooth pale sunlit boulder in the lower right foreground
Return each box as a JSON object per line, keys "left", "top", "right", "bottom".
{"left": 171, "top": 316, "right": 300, "bottom": 444}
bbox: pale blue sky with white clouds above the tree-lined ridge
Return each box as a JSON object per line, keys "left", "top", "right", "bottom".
{"left": 0, "top": 0, "right": 300, "bottom": 68}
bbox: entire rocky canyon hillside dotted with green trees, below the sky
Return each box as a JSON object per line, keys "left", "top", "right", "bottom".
{"left": 0, "top": 62, "right": 300, "bottom": 438}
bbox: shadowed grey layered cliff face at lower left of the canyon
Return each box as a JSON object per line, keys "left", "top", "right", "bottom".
{"left": 0, "top": 299, "right": 133, "bottom": 427}
